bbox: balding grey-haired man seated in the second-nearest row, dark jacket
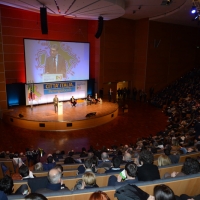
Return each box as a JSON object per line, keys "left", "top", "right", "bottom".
{"left": 36, "top": 168, "right": 69, "bottom": 193}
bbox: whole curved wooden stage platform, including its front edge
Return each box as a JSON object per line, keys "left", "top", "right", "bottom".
{"left": 3, "top": 102, "right": 118, "bottom": 131}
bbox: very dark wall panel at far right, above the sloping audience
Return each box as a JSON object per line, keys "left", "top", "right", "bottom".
{"left": 145, "top": 21, "right": 200, "bottom": 91}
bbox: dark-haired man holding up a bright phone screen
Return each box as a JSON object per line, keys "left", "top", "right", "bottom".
{"left": 108, "top": 163, "right": 138, "bottom": 186}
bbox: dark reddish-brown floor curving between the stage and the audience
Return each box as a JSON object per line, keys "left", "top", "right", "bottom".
{"left": 0, "top": 100, "right": 167, "bottom": 153}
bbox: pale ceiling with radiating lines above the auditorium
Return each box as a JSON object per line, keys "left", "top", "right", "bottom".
{"left": 0, "top": 0, "right": 199, "bottom": 26}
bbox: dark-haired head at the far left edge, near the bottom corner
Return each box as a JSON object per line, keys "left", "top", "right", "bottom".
{"left": 0, "top": 175, "right": 14, "bottom": 195}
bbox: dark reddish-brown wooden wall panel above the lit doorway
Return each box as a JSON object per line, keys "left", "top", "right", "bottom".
{"left": 100, "top": 19, "right": 135, "bottom": 89}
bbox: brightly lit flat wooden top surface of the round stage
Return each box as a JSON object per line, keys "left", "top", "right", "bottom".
{"left": 5, "top": 102, "right": 118, "bottom": 122}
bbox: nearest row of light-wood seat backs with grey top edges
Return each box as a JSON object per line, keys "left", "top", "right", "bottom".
{"left": 8, "top": 173, "right": 200, "bottom": 200}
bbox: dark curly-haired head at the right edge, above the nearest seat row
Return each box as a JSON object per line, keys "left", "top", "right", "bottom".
{"left": 181, "top": 157, "right": 200, "bottom": 175}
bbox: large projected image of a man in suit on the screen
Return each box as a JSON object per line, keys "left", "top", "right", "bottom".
{"left": 24, "top": 39, "right": 89, "bottom": 83}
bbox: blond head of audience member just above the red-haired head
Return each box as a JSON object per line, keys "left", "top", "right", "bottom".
{"left": 82, "top": 172, "right": 99, "bottom": 189}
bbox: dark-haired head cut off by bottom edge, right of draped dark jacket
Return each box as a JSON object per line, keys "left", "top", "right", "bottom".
{"left": 154, "top": 184, "right": 176, "bottom": 200}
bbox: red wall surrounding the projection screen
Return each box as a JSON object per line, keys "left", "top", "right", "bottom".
{"left": 0, "top": 5, "right": 100, "bottom": 109}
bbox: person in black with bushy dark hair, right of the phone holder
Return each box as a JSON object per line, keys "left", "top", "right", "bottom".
{"left": 137, "top": 150, "right": 160, "bottom": 181}
